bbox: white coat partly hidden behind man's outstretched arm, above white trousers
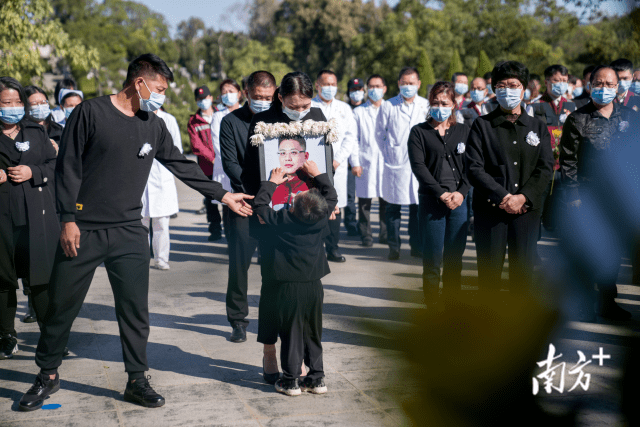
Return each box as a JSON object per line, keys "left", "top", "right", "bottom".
{"left": 142, "top": 110, "right": 182, "bottom": 218}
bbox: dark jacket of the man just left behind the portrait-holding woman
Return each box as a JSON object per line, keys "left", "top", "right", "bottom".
{"left": 220, "top": 102, "right": 253, "bottom": 193}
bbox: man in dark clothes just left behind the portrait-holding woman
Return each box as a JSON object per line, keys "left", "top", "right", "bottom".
{"left": 220, "top": 71, "right": 276, "bottom": 343}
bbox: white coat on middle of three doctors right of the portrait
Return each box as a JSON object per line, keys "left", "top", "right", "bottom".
{"left": 349, "top": 101, "right": 386, "bottom": 199}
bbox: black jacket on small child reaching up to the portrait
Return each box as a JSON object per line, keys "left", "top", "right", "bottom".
{"left": 254, "top": 173, "right": 338, "bottom": 282}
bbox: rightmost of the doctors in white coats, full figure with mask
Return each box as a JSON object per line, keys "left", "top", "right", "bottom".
{"left": 376, "top": 67, "right": 429, "bottom": 260}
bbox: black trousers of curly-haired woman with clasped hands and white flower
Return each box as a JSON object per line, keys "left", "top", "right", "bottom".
{"left": 474, "top": 208, "right": 540, "bottom": 293}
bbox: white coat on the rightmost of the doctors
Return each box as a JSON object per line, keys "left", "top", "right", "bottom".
{"left": 376, "top": 95, "right": 429, "bottom": 205}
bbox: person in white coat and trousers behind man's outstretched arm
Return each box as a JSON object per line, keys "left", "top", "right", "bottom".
{"left": 142, "top": 110, "right": 182, "bottom": 270}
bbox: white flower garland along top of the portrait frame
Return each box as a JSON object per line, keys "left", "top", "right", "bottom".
{"left": 251, "top": 119, "right": 339, "bottom": 146}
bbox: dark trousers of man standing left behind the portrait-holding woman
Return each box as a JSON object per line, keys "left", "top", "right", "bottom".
{"left": 225, "top": 211, "right": 258, "bottom": 326}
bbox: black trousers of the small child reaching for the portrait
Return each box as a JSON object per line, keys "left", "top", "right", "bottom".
{"left": 277, "top": 280, "right": 324, "bottom": 380}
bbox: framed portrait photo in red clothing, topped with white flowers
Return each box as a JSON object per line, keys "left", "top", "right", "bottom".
{"left": 251, "top": 120, "right": 337, "bottom": 210}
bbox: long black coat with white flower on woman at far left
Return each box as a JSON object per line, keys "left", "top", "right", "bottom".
{"left": 0, "top": 120, "right": 60, "bottom": 286}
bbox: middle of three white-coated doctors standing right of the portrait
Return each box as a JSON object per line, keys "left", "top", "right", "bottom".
{"left": 349, "top": 74, "right": 387, "bottom": 247}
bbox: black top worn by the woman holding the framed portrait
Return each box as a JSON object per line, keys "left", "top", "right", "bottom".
{"left": 241, "top": 104, "right": 333, "bottom": 201}
